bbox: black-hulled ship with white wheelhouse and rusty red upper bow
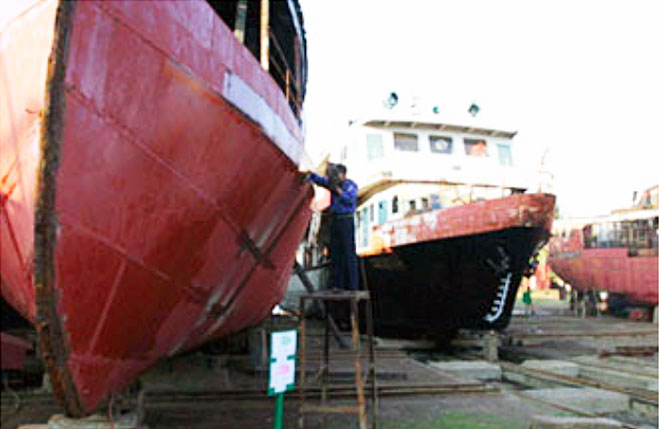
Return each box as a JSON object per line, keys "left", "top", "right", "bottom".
{"left": 305, "top": 94, "right": 555, "bottom": 338}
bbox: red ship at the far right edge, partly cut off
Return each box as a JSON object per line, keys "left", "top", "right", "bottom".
{"left": 549, "top": 185, "right": 659, "bottom": 312}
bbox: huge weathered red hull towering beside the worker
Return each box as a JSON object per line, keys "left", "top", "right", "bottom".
{"left": 0, "top": 1, "right": 312, "bottom": 415}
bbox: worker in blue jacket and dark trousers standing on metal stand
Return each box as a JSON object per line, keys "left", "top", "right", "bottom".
{"left": 309, "top": 164, "right": 359, "bottom": 290}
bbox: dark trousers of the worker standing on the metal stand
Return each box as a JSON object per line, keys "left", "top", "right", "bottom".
{"left": 330, "top": 215, "right": 359, "bottom": 290}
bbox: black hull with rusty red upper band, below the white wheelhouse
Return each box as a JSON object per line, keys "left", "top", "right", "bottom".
{"left": 360, "top": 194, "right": 555, "bottom": 339}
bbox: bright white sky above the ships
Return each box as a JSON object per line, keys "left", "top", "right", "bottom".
{"left": 302, "top": 0, "right": 659, "bottom": 216}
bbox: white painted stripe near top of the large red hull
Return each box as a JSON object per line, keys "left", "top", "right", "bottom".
{"left": 222, "top": 72, "right": 303, "bottom": 165}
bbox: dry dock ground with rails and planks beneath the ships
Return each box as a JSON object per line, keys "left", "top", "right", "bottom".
{"left": 2, "top": 294, "right": 658, "bottom": 429}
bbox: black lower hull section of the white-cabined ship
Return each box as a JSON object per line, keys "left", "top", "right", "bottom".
{"left": 362, "top": 227, "right": 549, "bottom": 338}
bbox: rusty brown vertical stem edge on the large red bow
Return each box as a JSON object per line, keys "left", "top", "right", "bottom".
{"left": 34, "top": 1, "right": 85, "bottom": 416}
